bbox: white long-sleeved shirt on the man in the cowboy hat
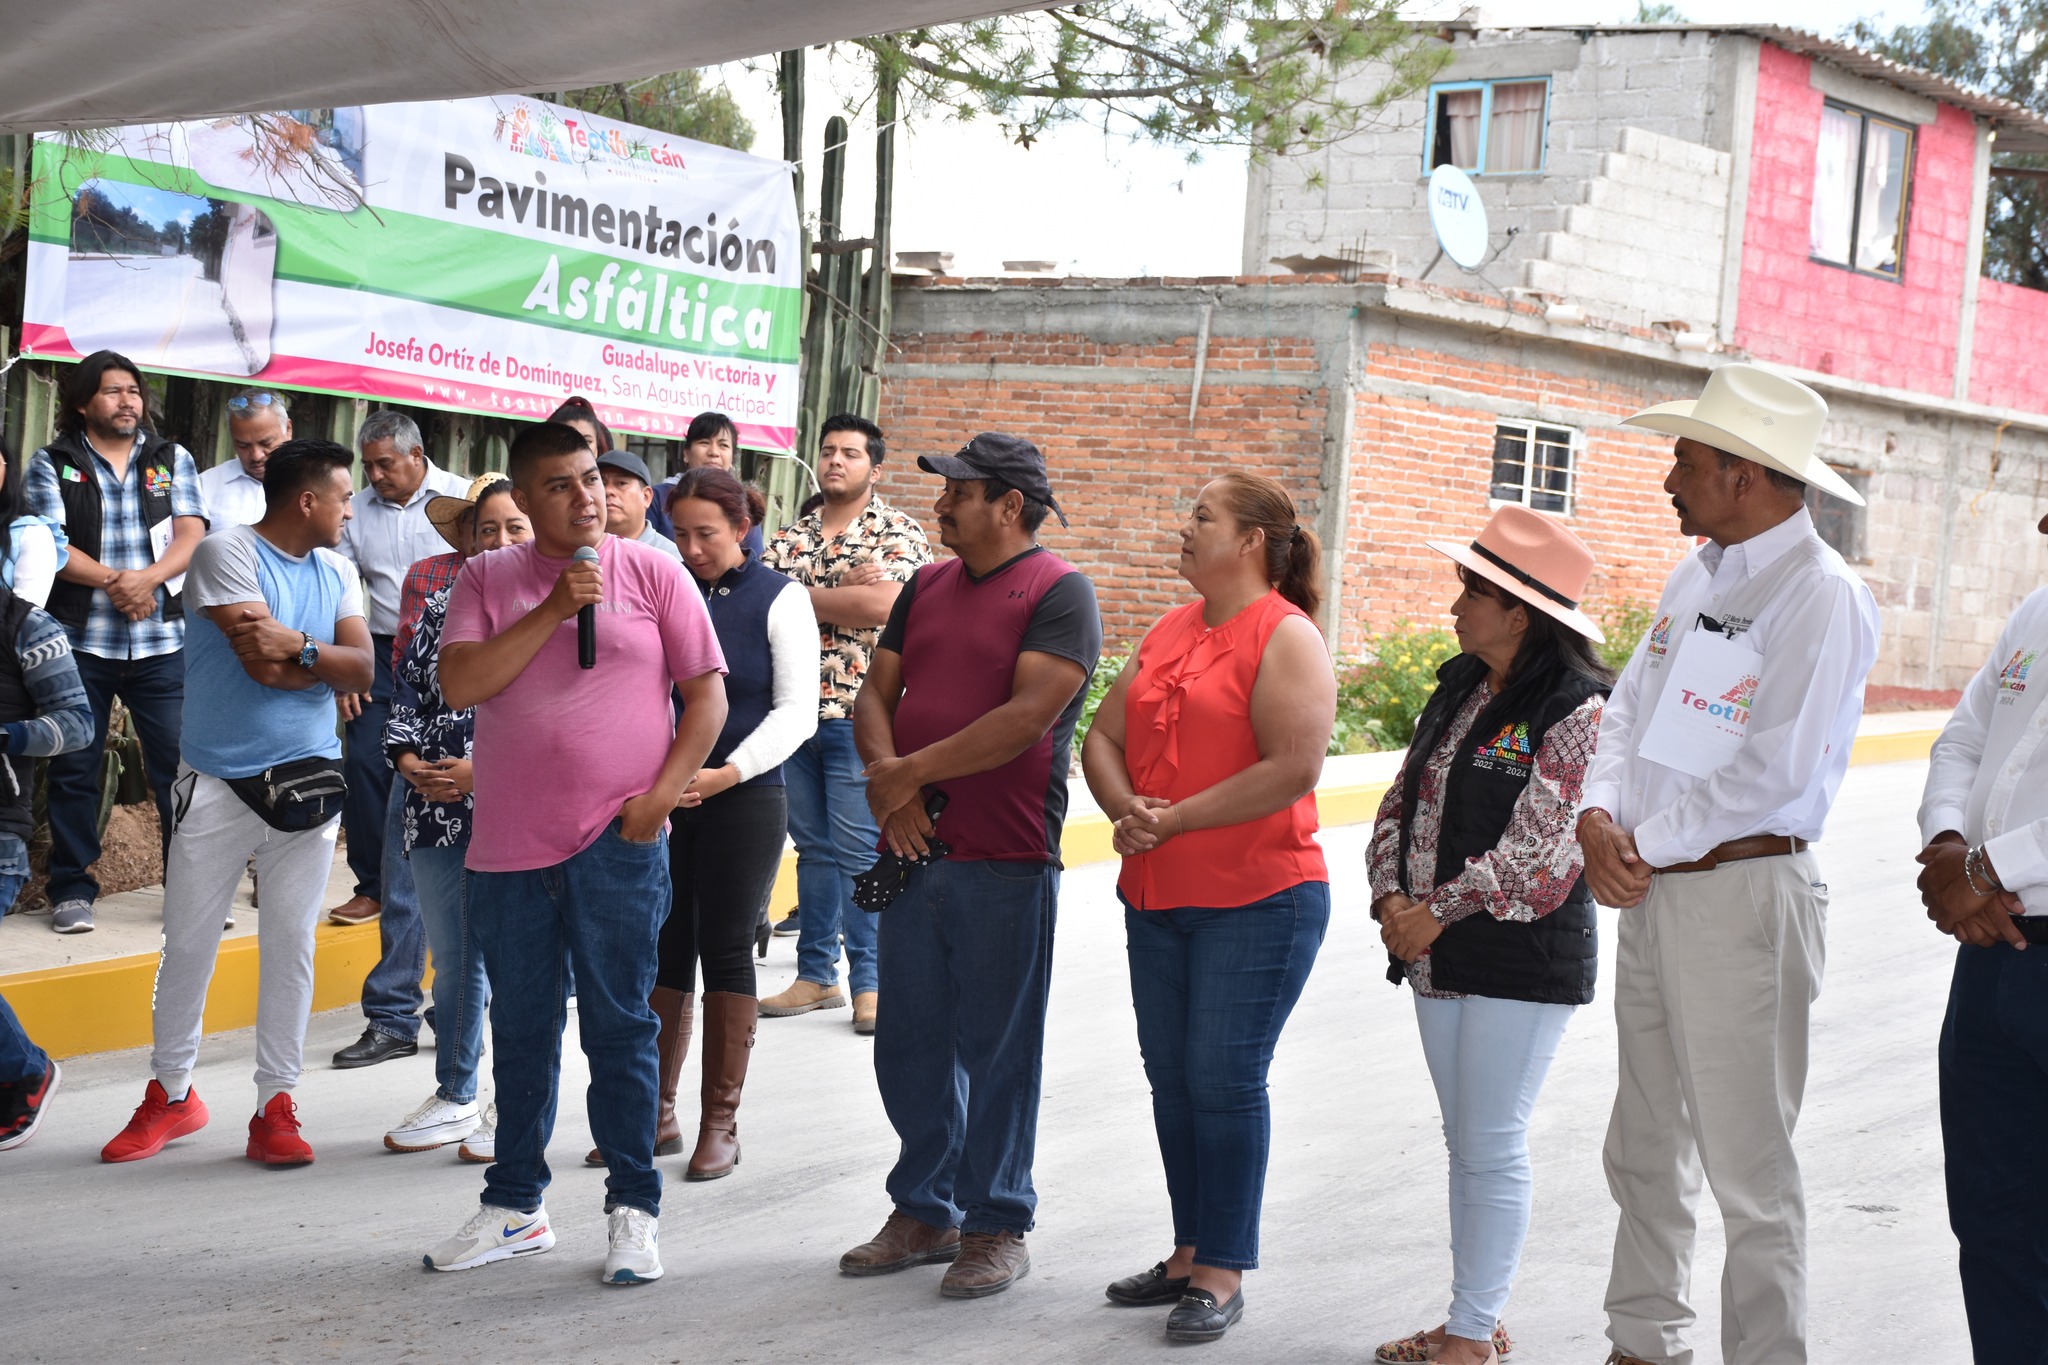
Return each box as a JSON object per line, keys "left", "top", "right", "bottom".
{"left": 1579, "top": 508, "right": 1878, "bottom": 868}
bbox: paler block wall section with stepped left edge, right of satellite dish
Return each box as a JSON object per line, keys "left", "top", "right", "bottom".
{"left": 1522, "top": 127, "right": 1731, "bottom": 332}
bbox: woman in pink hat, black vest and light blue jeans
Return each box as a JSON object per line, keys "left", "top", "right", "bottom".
{"left": 1368, "top": 508, "right": 1614, "bottom": 1365}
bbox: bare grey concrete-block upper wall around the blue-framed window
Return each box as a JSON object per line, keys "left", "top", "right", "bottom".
{"left": 1243, "top": 31, "right": 1731, "bottom": 296}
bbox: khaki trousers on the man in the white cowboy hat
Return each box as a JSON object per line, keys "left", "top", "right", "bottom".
{"left": 1604, "top": 853, "right": 1827, "bottom": 1365}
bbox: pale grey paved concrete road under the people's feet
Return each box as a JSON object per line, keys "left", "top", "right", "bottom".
{"left": 0, "top": 763, "right": 1968, "bottom": 1365}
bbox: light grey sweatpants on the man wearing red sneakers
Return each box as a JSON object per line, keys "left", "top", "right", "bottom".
{"left": 150, "top": 765, "right": 340, "bottom": 1099}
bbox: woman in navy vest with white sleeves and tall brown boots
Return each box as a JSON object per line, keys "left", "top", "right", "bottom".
{"left": 630, "top": 467, "right": 817, "bottom": 1181}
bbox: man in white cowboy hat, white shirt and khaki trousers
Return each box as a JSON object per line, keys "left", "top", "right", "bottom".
{"left": 1579, "top": 364, "right": 1878, "bottom": 1365}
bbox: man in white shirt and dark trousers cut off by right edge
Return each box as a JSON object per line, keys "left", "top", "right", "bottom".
{"left": 1919, "top": 507, "right": 2048, "bottom": 1361}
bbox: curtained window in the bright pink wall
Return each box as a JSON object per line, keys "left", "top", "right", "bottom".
{"left": 1808, "top": 104, "right": 1913, "bottom": 280}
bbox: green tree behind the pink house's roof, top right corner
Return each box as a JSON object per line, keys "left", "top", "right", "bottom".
{"left": 1841, "top": 0, "right": 2048, "bottom": 289}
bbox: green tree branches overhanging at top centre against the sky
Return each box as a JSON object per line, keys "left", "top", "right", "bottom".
{"left": 856, "top": 0, "right": 1450, "bottom": 156}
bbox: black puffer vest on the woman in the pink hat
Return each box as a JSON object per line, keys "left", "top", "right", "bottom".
{"left": 1386, "top": 655, "right": 1606, "bottom": 1005}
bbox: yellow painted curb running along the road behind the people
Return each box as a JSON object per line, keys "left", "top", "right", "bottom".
{"left": 0, "top": 731, "right": 1939, "bottom": 1056}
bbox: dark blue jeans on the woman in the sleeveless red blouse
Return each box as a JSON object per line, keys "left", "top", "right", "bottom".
{"left": 1124, "top": 882, "right": 1329, "bottom": 1271}
